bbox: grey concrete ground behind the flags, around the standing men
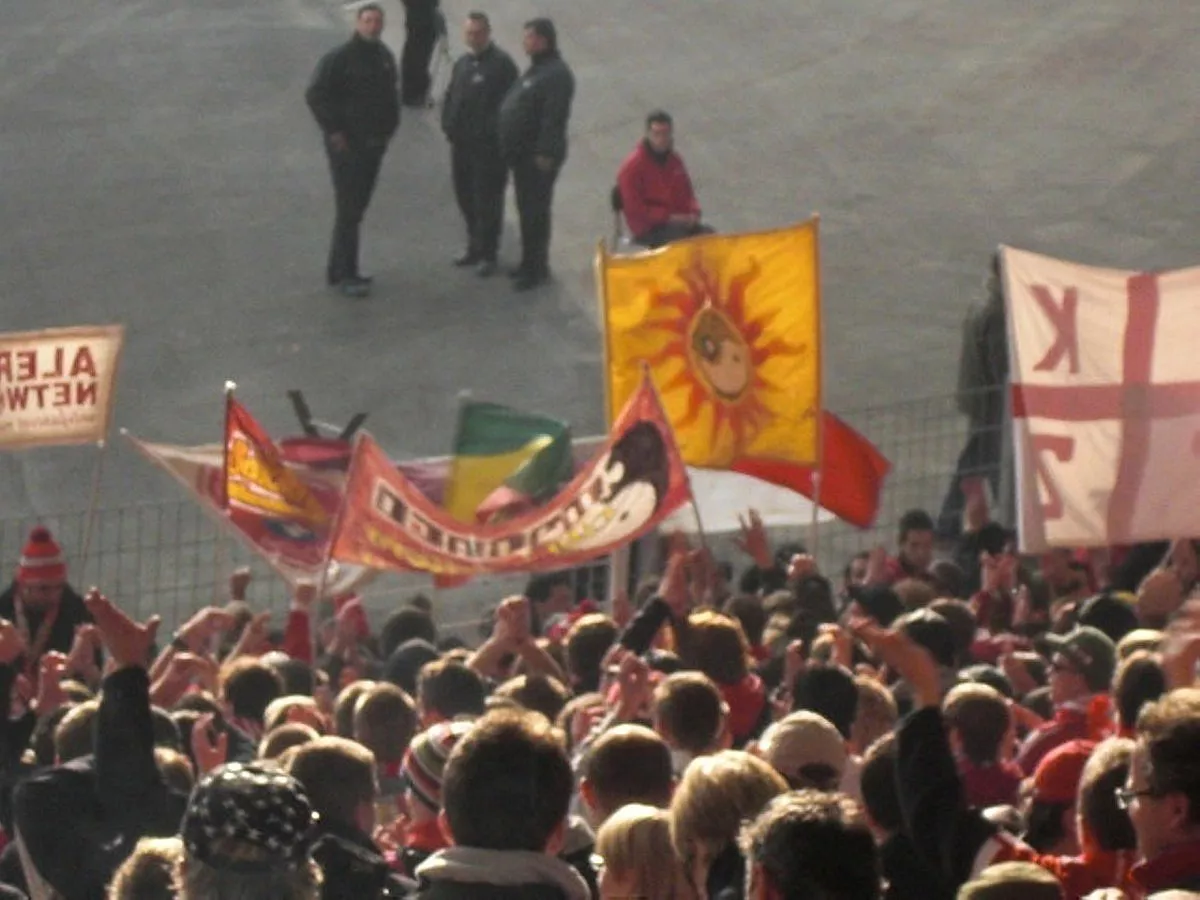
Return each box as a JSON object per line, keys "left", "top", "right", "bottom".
{"left": 0, "top": 0, "right": 1200, "bottom": 619}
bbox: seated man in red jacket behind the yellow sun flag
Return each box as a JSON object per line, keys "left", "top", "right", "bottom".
{"left": 617, "top": 109, "right": 713, "bottom": 247}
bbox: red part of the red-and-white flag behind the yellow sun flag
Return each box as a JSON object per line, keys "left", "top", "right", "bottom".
{"left": 730, "top": 410, "right": 892, "bottom": 528}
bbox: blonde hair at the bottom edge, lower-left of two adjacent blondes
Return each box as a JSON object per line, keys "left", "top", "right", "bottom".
{"left": 596, "top": 803, "right": 694, "bottom": 900}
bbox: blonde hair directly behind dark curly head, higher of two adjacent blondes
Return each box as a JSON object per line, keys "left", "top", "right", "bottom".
{"left": 671, "top": 750, "right": 787, "bottom": 859}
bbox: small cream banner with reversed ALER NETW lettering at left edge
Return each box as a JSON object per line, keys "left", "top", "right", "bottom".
{"left": 0, "top": 325, "right": 125, "bottom": 450}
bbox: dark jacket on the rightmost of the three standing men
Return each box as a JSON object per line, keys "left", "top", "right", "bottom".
{"left": 500, "top": 50, "right": 575, "bottom": 163}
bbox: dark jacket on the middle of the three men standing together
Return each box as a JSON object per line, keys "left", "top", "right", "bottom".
{"left": 442, "top": 43, "right": 517, "bottom": 146}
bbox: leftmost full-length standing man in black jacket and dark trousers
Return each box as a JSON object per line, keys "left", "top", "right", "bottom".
{"left": 305, "top": 4, "right": 400, "bottom": 296}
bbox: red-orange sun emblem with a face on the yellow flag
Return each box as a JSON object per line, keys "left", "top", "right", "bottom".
{"left": 643, "top": 250, "right": 808, "bottom": 456}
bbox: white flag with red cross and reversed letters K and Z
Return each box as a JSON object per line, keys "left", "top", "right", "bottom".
{"left": 1003, "top": 247, "right": 1200, "bottom": 552}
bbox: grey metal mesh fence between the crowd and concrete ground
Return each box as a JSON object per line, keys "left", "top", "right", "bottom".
{"left": 0, "top": 395, "right": 993, "bottom": 640}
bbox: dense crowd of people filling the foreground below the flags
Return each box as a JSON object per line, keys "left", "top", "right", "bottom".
{"left": 0, "top": 502, "right": 1200, "bottom": 900}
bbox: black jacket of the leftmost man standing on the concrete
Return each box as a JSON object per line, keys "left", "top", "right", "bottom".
{"left": 305, "top": 35, "right": 400, "bottom": 144}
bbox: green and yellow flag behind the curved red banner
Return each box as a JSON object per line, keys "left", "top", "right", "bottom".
{"left": 445, "top": 401, "right": 574, "bottom": 522}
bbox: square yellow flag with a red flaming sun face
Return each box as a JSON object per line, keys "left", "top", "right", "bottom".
{"left": 596, "top": 218, "right": 821, "bottom": 469}
